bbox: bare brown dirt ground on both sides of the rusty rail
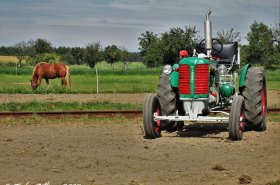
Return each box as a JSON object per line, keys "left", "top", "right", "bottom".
{"left": 0, "top": 94, "right": 280, "bottom": 185}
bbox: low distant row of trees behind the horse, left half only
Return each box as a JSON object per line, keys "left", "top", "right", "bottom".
{"left": 0, "top": 38, "right": 142, "bottom": 68}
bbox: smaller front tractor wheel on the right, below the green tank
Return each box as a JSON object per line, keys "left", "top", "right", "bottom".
{"left": 229, "top": 95, "right": 245, "bottom": 141}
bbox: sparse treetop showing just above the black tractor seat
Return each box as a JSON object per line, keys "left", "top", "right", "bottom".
{"left": 217, "top": 28, "right": 241, "bottom": 43}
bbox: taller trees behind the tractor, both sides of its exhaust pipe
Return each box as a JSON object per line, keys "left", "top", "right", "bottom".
{"left": 138, "top": 21, "right": 280, "bottom": 69}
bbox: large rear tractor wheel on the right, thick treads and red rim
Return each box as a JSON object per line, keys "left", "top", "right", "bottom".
{"left": 242, "top": 67, "right": 267, "bottom": 131}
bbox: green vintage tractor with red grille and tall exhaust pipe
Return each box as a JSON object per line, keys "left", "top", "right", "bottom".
{"left": 143, "top": 11, "right": 267, "bottom": 141}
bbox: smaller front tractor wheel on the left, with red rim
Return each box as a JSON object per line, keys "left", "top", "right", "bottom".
{"left": 143, "top": 94, "right": 161, "bottom": 139}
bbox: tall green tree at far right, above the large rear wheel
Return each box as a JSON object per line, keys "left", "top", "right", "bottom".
{"left": 245, "top": 21, "right": 273, "bottom": 68}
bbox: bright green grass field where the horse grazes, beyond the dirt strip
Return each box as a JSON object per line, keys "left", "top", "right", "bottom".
{"left": 0, "top": 62, "right": 280, "bottom": 94}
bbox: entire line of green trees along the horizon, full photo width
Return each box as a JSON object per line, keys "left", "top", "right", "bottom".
{"left": 0, "top": 21, "right": 280, "bottom": 69}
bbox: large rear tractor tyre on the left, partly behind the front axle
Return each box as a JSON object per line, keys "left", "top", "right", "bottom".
{"left": 157, "top": 73, "right": 182, "bottom": 132}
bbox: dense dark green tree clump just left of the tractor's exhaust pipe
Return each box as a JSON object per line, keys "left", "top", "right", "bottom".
{"left": 138, "top": 27, "right": 198, "bottom": 67}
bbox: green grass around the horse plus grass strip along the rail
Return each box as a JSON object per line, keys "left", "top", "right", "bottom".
{"left": 0, "top": 58, "right": 280, "bottom": 112}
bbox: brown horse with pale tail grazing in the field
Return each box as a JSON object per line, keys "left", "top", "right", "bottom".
{"left": 31, "top": 62, "right": 70, "bottom": 90}
